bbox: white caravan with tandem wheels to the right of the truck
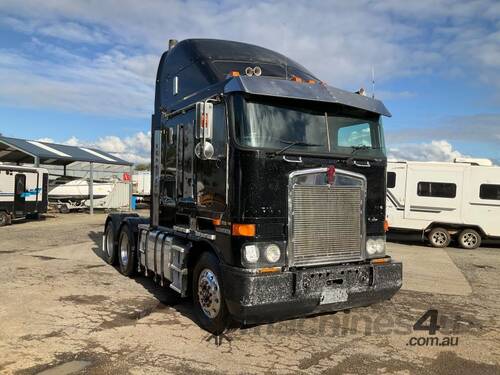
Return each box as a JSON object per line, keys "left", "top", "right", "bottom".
{"left": 387, "top": 158, "right": 500, "bottom": 249}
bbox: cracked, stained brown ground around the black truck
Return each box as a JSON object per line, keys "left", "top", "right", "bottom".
{"left": 0, "top": 214, "right": 500, "bottom": 375}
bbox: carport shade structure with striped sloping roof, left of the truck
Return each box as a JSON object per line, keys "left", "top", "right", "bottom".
{"left": 0, "top": 136, "right": 132, "bottom": 214}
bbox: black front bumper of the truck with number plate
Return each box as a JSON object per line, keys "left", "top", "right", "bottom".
{"left": 223, "top": 262, "right": 402, "bottom": 324}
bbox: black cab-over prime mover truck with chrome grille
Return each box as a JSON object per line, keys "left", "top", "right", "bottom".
{"left": 103, "top": 39, "right": 402, "bottom": 333}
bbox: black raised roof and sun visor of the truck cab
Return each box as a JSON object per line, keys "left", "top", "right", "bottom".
{"left": 155, "top": 39, "right": 391, "bottom": 116}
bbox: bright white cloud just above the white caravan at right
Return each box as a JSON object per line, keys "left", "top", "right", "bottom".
{"left": 388, "top": 140, "right": 467, "bottom": 161}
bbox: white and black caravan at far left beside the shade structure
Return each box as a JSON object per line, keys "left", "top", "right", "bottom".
{"left": 0, "top": 164, "right": 49, "bottom": 226}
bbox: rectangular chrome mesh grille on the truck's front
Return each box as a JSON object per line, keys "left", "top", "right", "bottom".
{"left": 289, "top": 184, "right": 364, "bottom": 266}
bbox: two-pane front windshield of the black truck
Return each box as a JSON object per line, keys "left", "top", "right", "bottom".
{"left": 234, "top": 97, "right": 385, "bottom": 156}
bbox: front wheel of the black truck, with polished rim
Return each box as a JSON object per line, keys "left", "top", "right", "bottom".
{"left": 192, "top": 252, "right": 229, "bottom": 335}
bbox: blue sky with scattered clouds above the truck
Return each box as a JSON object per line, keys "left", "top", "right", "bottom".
{"left": 0, "top": 0, "right": 500, "bottom": 163}
